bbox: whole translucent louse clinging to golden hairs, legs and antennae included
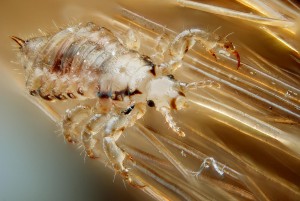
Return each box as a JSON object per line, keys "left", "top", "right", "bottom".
{"left": 11, "top": 23, "right": 240, "bottom": 186}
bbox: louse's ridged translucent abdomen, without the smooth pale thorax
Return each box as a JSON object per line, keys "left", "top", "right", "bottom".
{"left": 27, "top": 24, "right": 117, "bottom": 101}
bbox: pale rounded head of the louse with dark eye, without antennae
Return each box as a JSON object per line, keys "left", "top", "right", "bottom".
{"left": 147, "top": 75, "right": 187, "bottom": 110}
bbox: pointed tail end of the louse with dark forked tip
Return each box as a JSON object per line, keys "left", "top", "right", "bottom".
{"left": 11, "top": 36, "right": 48, "bottom": 69}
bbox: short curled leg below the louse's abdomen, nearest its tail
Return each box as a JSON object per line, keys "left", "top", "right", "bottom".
{"left": 62, "top": 105, "right": 91, "bottom": 143}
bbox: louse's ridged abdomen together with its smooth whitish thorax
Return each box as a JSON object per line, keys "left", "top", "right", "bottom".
{"left": 27, "top": 23, "right": 151, "bottom": 101}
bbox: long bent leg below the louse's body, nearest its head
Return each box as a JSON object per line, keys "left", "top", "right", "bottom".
{"left": 103, "top": 104, "right": 146, "bottom": 187}
